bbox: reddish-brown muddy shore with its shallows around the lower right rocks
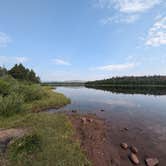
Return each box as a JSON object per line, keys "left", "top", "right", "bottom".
{"left": 68, "top": 112, "right": 166, "bottom": 166}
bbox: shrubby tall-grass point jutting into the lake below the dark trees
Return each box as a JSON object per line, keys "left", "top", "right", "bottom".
{"left": 0, "top": 76, "right": 70, "bottom": 117}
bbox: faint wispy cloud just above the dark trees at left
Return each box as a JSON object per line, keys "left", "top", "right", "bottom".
{"left": 0, "top": 56, "right": 28, "bottom": 65}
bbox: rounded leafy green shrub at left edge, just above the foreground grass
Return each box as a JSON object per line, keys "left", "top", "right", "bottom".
{"left": 0, "top": 93, "right": 23, "bottom": 116}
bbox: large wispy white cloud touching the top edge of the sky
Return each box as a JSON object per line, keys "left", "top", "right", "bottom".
{"left": 96, "top": 0, "right": 163, "bottom": 24}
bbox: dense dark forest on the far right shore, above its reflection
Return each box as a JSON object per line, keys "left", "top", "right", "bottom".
{"left": 85, "top": 76, "right": 166, "bottom": 87}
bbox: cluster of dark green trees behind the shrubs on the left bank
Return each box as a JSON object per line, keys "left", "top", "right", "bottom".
{"left": 0, "top": 64, "right": 40, "bottom": 83}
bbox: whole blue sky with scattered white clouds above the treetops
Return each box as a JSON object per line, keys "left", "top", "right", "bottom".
{"left": 0, "top": 0, "right": 166, "bottom": 81}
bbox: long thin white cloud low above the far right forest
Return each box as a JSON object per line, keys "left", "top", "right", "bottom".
{"left": 91, "top": 63, "right": 135, "bottom": 71}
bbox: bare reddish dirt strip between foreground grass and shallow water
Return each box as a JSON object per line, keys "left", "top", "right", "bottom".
{"left": 69, "top": 115, "right": 120, "bottom": 166}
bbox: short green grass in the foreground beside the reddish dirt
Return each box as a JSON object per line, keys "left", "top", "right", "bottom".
{"left": 0, "top": 113, "right": 91, "bottom": 166}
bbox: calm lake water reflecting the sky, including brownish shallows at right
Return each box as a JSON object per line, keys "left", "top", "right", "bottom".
{"left": 50, "top": 87, "right": 166, "bottom": 162}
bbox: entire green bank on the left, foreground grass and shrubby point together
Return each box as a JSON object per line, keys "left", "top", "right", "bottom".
{"left": 0, "top": 77, "right": 90, "bottom": 166}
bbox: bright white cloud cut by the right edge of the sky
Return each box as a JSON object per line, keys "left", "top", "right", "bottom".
{"left": 146, "top": 16, "right": 166, "bottom": 46}
